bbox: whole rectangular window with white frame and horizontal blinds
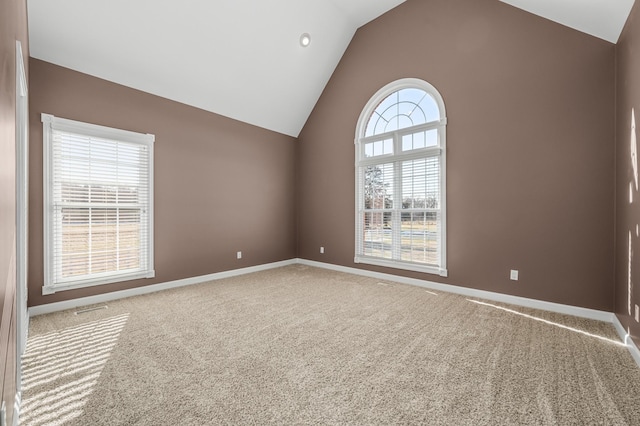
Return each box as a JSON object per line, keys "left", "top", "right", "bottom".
{"left": 42, "top": 114, "right": 155, "bottom": 294}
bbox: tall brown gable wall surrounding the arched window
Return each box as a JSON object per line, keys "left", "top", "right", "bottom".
{"left": 297, "top": 0, "right": 615, "bottom": 311}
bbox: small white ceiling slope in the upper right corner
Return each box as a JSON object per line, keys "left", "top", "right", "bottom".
{"left": 500, "top": 0, "right": 635, "bottom": 43}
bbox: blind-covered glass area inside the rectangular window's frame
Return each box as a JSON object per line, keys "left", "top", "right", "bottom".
{"left": 53, "top": 131, "right": 149, "bottom": 279}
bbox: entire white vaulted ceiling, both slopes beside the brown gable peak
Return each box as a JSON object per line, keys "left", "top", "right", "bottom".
{"left": 28, "top": 0, "right": 634, "bottom": 136}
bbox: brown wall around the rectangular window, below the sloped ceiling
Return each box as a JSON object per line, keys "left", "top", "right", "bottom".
{"left": 29, "top": 58, "right": 296, "bottom": 306}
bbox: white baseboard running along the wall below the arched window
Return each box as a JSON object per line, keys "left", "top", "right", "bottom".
{"left": 297, "top": 259, "right": 615, "bottom": 323}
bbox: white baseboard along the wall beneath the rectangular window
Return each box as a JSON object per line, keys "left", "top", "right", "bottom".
{"left": 29, "top": 259, "right": 297, "bottom": 317}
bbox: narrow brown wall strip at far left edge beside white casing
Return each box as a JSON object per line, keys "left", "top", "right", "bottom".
{"left": 0, "top": 0, "right": 29, "bottom": 424}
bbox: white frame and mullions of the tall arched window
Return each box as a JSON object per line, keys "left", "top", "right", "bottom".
{"left": 354, "top": 78, "right": 448, "bottom": 277}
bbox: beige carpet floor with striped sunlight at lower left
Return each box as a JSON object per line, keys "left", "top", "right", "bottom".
{"left": 21, "top": 265, "right": 640, "bottom": 426}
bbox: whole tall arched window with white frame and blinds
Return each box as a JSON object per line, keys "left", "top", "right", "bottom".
{"left": 355, "top": 79, "right": 447, "bottom": 276}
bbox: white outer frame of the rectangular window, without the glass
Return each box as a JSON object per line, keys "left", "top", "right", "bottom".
{"left": 41, "top": 113, "right": 155, "bottom": 294}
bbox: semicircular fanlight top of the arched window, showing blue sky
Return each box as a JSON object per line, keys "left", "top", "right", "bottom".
{"left": 356, "top": 78, "right": 446, "bottom": 139}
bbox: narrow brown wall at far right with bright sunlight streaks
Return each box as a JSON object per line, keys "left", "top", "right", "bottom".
{"left": 615, "top": 2, "right": 640, "bottom": 345}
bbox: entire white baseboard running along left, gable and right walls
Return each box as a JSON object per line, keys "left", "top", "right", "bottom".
{"left": 29, "top": 258, "right": 640, "bottom": 366}
